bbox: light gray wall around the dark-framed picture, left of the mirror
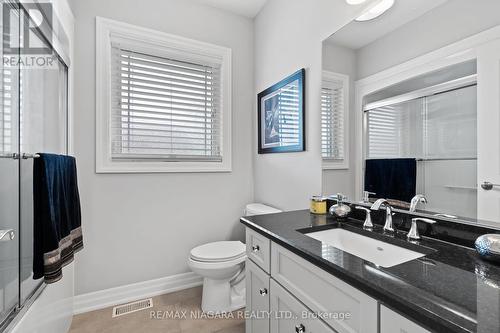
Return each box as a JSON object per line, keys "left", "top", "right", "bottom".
{"left": 253, "top": 0, "right": 372, "bottom": 210}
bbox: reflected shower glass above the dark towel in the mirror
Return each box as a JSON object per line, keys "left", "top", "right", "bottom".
{"left": 366, "top": 86, "right": 477, "bottom": 159}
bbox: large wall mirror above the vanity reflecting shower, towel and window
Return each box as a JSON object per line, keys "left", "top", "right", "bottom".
{"left": 321, "top": 0, "right": 500, "bottom": 219}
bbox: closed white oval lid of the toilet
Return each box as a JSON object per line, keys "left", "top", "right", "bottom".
{"left": 191, "top": 241, "right": 246, "bottom": 262}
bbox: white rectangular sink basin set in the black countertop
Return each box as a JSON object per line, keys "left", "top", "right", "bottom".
{"left": 305, "top": 229, "right": 425, "bottom": 267}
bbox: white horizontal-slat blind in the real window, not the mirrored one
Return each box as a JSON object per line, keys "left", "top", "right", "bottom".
{"left": 111, "top": 45, "right": 222, "bottom": 162}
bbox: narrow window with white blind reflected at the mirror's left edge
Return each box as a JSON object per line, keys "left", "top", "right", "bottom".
{"left": 321, "top": 71, "right": 349, "bottom": 169}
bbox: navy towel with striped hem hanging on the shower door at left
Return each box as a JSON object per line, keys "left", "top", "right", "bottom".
{"left": 33, "top": 154, "right": 83, "bottom": 283}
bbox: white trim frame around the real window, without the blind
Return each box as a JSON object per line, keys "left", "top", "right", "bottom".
{"left": 96, "top": 17, "right": 232, "bottom": 173}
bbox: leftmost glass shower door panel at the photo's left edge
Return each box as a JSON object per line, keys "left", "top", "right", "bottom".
{"left": 0, "top": 1, "right": 19, "bottom": 329}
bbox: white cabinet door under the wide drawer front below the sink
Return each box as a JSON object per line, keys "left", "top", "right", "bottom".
{"left": 271, "top": 279, "right": 336, "bottom": 333}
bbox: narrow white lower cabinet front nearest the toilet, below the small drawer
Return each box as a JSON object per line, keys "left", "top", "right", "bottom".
{"left": 245, "top": 259, "right": 270, "bottom": 333}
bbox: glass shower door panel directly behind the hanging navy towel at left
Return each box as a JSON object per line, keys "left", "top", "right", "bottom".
{"left": 19, "top": 8, "right": 68, "bottom": 304}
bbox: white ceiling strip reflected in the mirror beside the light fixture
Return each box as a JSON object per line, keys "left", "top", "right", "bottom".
{"left": 327, "top": 0, "right": 449, "bottom": 50}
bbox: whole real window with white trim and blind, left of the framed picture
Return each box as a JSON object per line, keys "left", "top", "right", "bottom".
{"left": 96, "top": 18, "right": 231, "bottom": 172}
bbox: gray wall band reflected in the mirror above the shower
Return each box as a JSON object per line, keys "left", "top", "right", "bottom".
{"left": 358, "top": 0, "right": 500, "bottom": 78}
